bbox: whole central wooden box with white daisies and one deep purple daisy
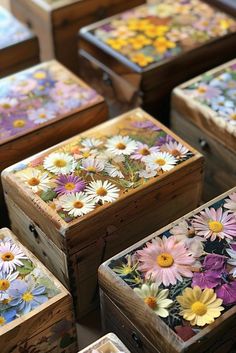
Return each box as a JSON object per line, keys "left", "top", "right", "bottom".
{"left": 2, "top": 109, "right": 203, "bottom": 317}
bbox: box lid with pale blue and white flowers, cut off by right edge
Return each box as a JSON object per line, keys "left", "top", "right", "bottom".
{"left": 172, "top": 59, "right": 236, "bottom": 152}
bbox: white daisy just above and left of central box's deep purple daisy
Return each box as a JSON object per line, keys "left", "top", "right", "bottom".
{"left": 43, "top": 152, "right": 77, "bottom": 175}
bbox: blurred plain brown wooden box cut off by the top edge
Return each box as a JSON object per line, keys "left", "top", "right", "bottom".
{"left": 10, "top": 0, "right": 144, "bottom": 72}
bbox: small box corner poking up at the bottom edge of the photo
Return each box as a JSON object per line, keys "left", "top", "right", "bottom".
{"left": 78, "top": 333, "right": 130, "bottom": 353}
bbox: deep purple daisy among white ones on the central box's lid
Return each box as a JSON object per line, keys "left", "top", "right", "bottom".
{"left": 55, "top": 174, "right": 86, "bottom": 195}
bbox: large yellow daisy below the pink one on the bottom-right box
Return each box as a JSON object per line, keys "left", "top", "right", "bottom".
{"left": 176, "top": 286, "right": 224, "bottom": 326}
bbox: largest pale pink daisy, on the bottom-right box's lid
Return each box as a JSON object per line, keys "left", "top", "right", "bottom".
{"left": 137, "top": 236, "right": 195, "bottom": 286}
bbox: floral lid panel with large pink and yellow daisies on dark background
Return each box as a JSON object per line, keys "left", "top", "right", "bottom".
{"left": 109, "top": 192, "right": 236, "bottom": 340}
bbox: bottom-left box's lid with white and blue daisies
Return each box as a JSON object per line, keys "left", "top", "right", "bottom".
{"left": 0, "top": 228, "right": 73, "bottom": 342}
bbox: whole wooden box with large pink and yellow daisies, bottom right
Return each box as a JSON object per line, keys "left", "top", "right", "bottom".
{"left": 99, "top": 188, "right": 236, "bottom": 353}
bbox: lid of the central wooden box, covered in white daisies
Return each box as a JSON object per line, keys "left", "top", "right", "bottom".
{"left": 2, "top": 109, "right": 202, "bottom": 250}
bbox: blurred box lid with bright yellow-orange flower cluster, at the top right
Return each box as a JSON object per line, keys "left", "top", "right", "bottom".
{"left": 80, "top": 0, "right": 236, "bottom": 90}
